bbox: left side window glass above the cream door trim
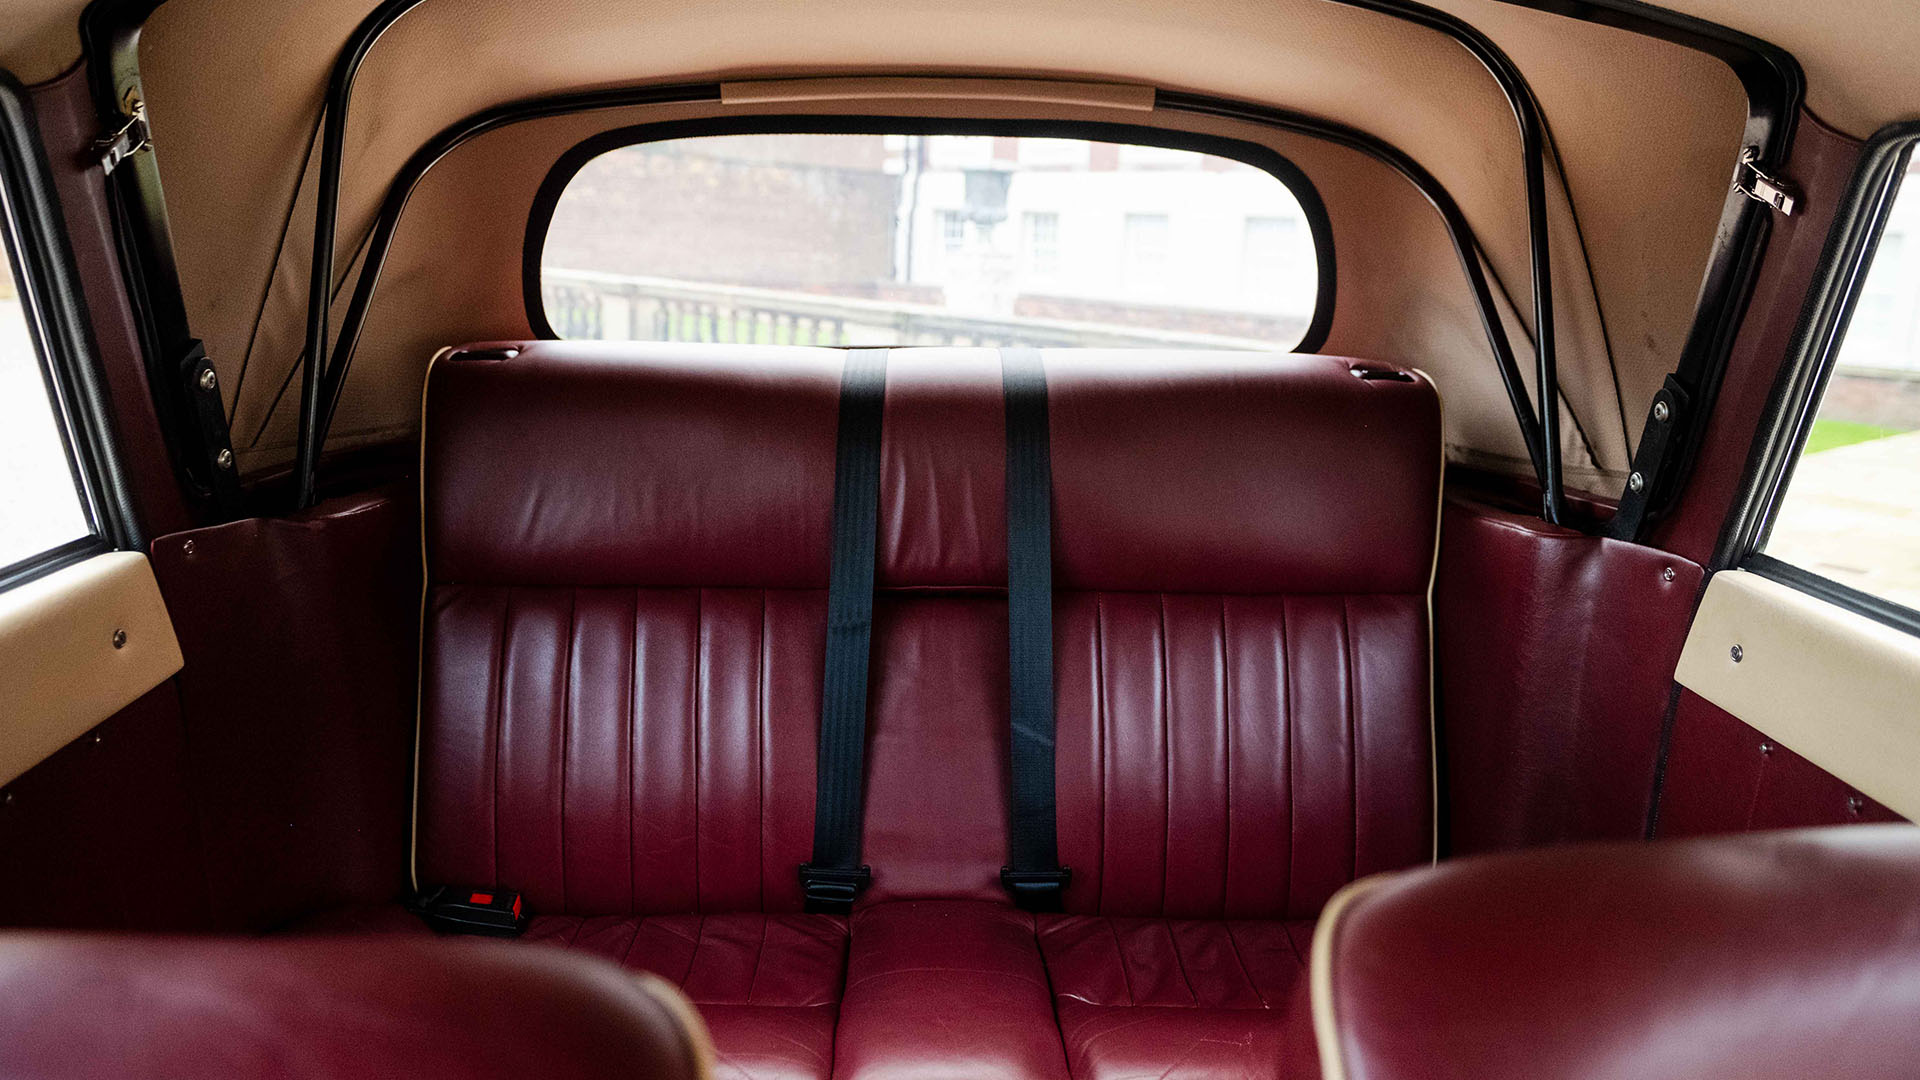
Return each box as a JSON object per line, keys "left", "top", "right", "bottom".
{"left": 0, "top": 153, "right": 104, "bottom": 586}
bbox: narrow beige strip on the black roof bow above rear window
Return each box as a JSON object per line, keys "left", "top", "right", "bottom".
{"left": 720, "top": 77, "right": 1154, "bottom": 111}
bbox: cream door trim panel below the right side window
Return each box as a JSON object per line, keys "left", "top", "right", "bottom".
{"left": 1674, "top": 571, "right": 1920, "bottom": 819}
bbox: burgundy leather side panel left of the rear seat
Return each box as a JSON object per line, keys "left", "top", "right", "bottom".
{"left": 154, "top": 488, "right": 420, "bottom": 928}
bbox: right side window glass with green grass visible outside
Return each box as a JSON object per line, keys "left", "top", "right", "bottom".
{"left": 1761, "top": 144, "right": 1920, "bottom": 611}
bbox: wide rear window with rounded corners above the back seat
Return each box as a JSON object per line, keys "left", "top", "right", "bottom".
{"left": 540, "top": 135, "right": 1321, "bottom": 350}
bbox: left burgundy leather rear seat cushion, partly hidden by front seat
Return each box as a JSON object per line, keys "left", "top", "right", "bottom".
{"left": 294, "top": 905, "right": 847, "bottom": 1080}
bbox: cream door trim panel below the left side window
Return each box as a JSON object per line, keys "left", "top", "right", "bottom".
{"left": 0, "top": 552, "right": 182, "bottom": 784}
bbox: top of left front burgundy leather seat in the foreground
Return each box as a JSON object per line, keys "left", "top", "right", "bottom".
{"left": 0, "top": 934, "right": 710, "bottom": 1080}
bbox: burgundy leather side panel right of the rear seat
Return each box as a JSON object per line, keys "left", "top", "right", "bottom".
{"left": 1434, "top": 498, "right": 1701, "bottom": 855}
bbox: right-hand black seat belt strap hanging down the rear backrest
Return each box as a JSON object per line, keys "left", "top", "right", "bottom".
{"left": 1000, "top": 348, "right": 1071, "bottom": 911}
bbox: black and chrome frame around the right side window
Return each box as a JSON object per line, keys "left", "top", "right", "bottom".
{"left": 1713, "top": 121, "right": 1920, "bottom": 636}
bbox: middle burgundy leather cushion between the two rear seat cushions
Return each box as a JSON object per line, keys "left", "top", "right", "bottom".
{"left": 833, "top": 901, "right": 1068, "bottom": 1080}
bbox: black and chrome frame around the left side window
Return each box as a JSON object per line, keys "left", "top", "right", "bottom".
{"left": 0, "top": 69, "right": 142, "bottom": 592}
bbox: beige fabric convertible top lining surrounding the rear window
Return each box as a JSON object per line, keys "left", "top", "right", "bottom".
{"left": 0, "top": 0, "right": 1920, "bottom": 490}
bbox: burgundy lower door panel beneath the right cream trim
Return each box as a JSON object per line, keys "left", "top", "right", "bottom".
{"left": 1655, "top": 690, "right": 1907, "bottom": 838}
